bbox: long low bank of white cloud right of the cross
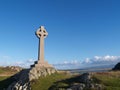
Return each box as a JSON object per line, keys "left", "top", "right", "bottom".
{"left": 54, "top": 55, "right": 120, "bottom": 69}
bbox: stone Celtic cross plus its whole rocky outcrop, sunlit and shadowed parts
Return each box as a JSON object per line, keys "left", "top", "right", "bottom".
{"left": 7, "top": 26, "right": 57, "bottom": 90}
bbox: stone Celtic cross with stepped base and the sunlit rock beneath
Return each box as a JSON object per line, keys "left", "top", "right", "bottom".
{"left": 29, "top": 26, "right": 57, "bottom": 81}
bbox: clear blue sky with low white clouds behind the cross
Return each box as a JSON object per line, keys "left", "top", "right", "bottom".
{"left": 0, "top": 0, "right": 120, "bottom": 69}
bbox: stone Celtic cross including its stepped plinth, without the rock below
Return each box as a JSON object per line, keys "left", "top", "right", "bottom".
{"left": 31, "top": 26, "right": 52, "bottom": 67}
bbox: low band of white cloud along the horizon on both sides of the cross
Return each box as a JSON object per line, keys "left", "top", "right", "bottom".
{"left": 0, "top": 55, "right": 120, "bottom": 69}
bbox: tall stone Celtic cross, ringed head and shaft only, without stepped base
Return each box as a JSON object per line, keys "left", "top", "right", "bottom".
{"left": 36, "top": 26, "right": 48, "bottom": 63}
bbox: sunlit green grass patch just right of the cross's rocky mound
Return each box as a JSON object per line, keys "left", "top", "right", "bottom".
{"left": 31, "top": 73, "right": 71, "bottom": 90}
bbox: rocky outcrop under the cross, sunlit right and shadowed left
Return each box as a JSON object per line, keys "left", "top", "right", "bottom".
{"left": 7, "top": 67, "right": 56, "bottom": 90}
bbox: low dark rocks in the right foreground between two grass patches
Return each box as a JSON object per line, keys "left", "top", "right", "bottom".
{"left": 66, "top": 73, "right": 103, "bottom": 90}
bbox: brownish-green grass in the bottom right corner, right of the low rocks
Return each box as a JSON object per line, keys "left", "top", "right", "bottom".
{"left": 93, "top": 71, "right": 120, "bottom": 90}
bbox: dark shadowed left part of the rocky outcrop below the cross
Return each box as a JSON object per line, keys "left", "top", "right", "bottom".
{"left": 7, "top": 69, "right": 30, "bottom": 90}
